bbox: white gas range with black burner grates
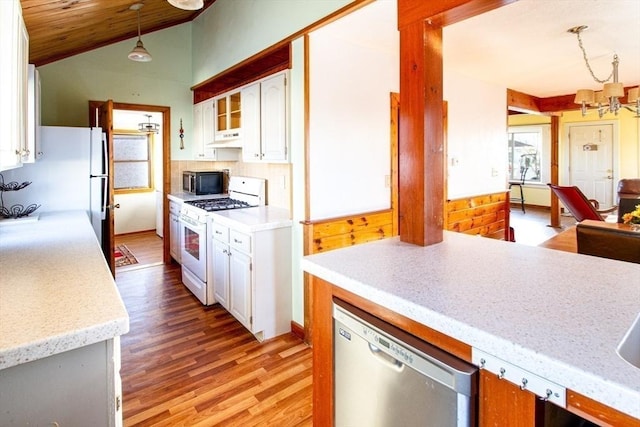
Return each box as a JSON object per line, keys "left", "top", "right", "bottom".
{"left": 180, "top": 176, "right": 266, "bottom": 305}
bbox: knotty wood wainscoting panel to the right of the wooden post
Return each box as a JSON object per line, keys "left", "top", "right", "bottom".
{"left": 445, "top": 191, "right": 509, "bottom": 240}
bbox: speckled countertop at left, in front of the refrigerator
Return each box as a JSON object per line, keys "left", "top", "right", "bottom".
{"left": 0, "top": 211, "right": 129, "bottom": 369}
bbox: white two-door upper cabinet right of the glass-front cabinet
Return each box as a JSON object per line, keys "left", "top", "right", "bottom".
{"left": 242, "top": 72, "right": 289, "bottom": 163}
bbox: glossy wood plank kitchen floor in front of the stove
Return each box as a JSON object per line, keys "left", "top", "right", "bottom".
{"left": 116, "top": 262, "right": 312, "bottom": 427}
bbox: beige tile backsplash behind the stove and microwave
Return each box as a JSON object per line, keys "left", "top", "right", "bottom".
{"left": 171, "top": 160, "right": 291, "bottom": 210}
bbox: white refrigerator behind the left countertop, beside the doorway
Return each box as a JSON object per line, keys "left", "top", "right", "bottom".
{"left": 0, "top": 126, "right": 108, "bottom": 244}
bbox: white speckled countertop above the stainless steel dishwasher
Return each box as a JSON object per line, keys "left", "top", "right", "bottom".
{"left": 301, "top": 232, "right": 640, "bottom": 418}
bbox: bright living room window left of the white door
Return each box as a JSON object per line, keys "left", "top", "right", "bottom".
{"left": 507, "top": 125, "right": 551, "bottom": 183}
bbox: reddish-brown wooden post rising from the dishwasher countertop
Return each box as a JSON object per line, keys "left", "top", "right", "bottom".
{"left": 399, "top": 21, "right": 444, "bottom": 246}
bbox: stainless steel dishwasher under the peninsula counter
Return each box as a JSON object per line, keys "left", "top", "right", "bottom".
{"left": 333, "top": 300, "right": 477, "bottom": 427}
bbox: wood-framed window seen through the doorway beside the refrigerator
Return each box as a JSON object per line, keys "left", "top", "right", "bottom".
{"left": 113, "top": 133, "right": 153, "bottom": 193}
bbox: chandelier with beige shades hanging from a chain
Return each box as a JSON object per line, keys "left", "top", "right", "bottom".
{"left": 567, "top": 25, "right": 640, "bottom": 118}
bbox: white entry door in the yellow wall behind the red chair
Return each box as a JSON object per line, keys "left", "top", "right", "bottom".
{"left": 569, "top": 123, "right": 614, "bottom": 207}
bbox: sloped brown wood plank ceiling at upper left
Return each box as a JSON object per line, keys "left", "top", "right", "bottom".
{"left": 20, "top": 0, "right": 215, "bottom": 66}
